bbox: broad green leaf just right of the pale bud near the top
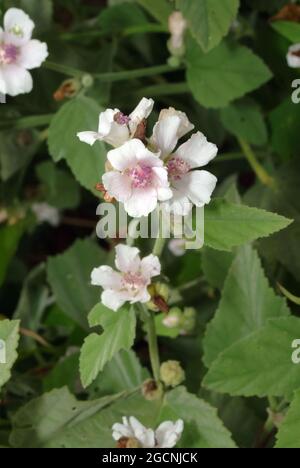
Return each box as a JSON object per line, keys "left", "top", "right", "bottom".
{"left": 187, "top": 40, "right": 272, "bottom": 108}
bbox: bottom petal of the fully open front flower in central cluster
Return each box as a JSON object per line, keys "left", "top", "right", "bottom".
{"left": 124, "top": 187, "right": 157, "bottom": 218}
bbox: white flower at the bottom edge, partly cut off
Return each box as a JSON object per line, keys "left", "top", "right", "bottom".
{"left": 112, "top": 416, "right": 184, "bottom": 448}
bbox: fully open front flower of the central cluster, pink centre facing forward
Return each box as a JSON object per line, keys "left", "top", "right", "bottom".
{"left": 102, "top": 139, "right": 172, "bottom": 218}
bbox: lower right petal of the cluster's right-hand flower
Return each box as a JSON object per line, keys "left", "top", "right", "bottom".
{"left": 176, "top": 171, "right": 218, "bottom": 207}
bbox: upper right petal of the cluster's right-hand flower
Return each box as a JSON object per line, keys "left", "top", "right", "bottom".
{"left": 175, "top": 132, "right": 218, "bottom": 169}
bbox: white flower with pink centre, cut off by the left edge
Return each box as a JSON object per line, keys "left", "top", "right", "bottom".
{"left": 0, "top": 8, "right": 48, "bottom": 96}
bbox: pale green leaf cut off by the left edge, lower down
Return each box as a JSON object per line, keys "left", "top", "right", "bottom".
{"left": 0, "top": 320, "right": 20, "bottom": 389}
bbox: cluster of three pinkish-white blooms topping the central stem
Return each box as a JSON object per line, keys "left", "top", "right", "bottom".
{"left": 78, "top": 98, "right": 218, "bottom": 218}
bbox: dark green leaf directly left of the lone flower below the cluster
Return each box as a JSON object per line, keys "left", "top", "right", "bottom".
{"left": 47, "top": 239, "right": 105, "bottom": 329}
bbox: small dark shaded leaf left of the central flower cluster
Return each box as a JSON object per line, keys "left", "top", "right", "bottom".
{"left": 36, "top": 161, "right": 80, "bottom": 210}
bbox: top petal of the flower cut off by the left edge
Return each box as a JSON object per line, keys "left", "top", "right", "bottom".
{"left": 4, "top": 8, "right": 34, "bottom": 45}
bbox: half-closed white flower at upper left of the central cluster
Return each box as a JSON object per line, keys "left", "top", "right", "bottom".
{"left": 77, "top": 98, "right": 154, "bottom": 148}
